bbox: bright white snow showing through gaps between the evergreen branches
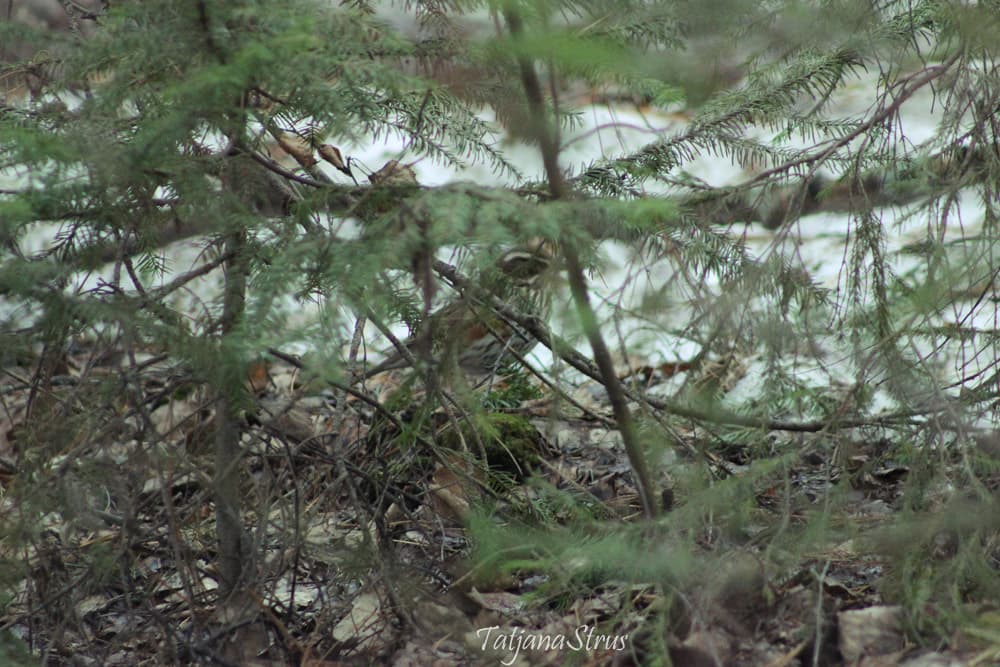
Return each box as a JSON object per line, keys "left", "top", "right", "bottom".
{"left": 0, "top": 58, "right": 996, "bottom": 422}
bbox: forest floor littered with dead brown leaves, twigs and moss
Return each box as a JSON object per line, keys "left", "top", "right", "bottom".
{"left": 0, "top": 350, "right": 1000, "bottom": 667}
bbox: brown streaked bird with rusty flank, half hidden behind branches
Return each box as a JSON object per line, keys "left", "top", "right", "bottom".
{"left": 364, "top": 240, "right": 555, "bottom": 379}
